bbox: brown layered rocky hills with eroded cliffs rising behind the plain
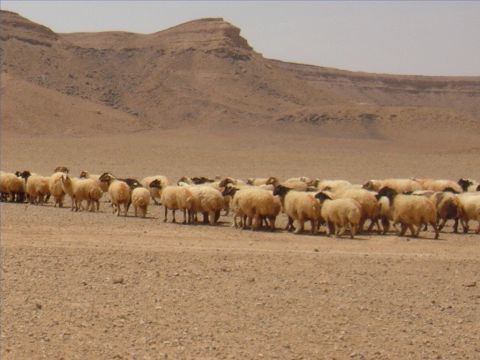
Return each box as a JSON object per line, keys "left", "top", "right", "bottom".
{"left": 0, "top": 11, "right": 480, "bottom": 138}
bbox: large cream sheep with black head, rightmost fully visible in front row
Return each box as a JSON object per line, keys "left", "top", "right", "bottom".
{"left": 375, "top": 187, "right": 438, "bottom": 239}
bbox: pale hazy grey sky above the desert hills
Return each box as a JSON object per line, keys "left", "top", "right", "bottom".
{"left": 0, "top": 0, "right": 480, "bottom": 76}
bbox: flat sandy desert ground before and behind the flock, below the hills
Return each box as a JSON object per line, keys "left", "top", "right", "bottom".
{"left": 1, "top": 129, "right": 480, "bottom": 359}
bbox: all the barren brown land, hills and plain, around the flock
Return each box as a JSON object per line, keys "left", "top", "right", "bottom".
{"left": 0, "top": 12, "right": 480, "bottom": 359}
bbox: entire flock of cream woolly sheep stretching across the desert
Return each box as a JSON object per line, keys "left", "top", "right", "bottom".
{"left": 0, "top": 167, "right": 480, "bottom": 239}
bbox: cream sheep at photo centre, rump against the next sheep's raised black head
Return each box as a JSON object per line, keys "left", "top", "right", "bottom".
{"left": 222, "top": 187, "right": 282, "bottom": 231}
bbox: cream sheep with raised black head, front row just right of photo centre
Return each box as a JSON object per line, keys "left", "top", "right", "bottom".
{"left": 273, "top": 185, "right": 321, "bottom": 234}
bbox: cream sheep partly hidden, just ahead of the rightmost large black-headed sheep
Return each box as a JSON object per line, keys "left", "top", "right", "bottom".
{"left": 334, "top": 187, "right": 380, "bottom": 232}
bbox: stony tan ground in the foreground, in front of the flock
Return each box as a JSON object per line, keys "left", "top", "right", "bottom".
{"left": 1, "top": 204, "right": 480, "bottom": 359}
